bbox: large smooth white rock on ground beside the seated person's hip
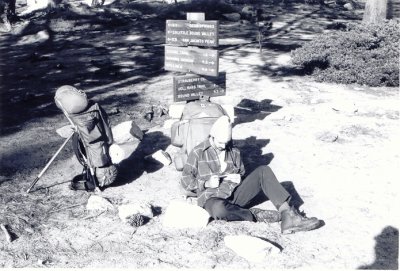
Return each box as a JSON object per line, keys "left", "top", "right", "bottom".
{"left": 163, "top": 200, "right": 210, "bottom": 229}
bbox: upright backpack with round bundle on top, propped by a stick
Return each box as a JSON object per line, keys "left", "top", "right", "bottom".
{"left": 55, "top": 86, "right": 118, "bottom": 191}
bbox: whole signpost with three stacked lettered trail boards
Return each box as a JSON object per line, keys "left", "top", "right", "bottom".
{"left": 164, "top": 13, "right": 226, "bottom": 102}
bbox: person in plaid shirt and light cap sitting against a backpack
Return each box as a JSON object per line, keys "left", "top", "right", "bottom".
{"left": 181, "top": 116, "right": 322, "bottom": 234}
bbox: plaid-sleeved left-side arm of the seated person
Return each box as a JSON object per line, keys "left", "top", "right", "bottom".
{"left": 181, "top": 150, "right": 205, "bottom": 192}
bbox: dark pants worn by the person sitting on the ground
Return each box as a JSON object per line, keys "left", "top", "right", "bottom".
{"left": 204, "top": 166, "right": 290, "bottom": 221}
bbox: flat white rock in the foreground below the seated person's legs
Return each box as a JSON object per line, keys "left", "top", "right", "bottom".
{"left": 224, "top": 235, "right": 280, "bottom": 262}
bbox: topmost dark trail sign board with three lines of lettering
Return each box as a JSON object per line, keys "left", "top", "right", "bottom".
{"left": 166, "top": 20, "right": 218, "bottom": 47}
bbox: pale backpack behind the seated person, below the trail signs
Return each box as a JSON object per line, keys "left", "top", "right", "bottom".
{"left": 171, "top": 96, "right": 228, "bottom": 171}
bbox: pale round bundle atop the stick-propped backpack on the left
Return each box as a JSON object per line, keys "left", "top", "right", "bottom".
{"left": 54, "top": 85, "right": 88, "bottom": 114}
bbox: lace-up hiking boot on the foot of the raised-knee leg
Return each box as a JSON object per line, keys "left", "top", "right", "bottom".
{"left": 281, "top": 207, "right": 321, "bottom": 234}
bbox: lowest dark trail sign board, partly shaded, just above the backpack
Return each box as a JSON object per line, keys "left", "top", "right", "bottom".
{"left": 174, "top": 72, "right": 226, "bottom": 102}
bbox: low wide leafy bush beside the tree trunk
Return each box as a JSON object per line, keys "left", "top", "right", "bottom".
{"left": 292, "top": 20, "right": 400, "bottom": 86}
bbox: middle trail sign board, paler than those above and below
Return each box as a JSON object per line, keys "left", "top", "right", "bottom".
{"left": 164, "top": 46, "right": 218, "bottom": 76}
